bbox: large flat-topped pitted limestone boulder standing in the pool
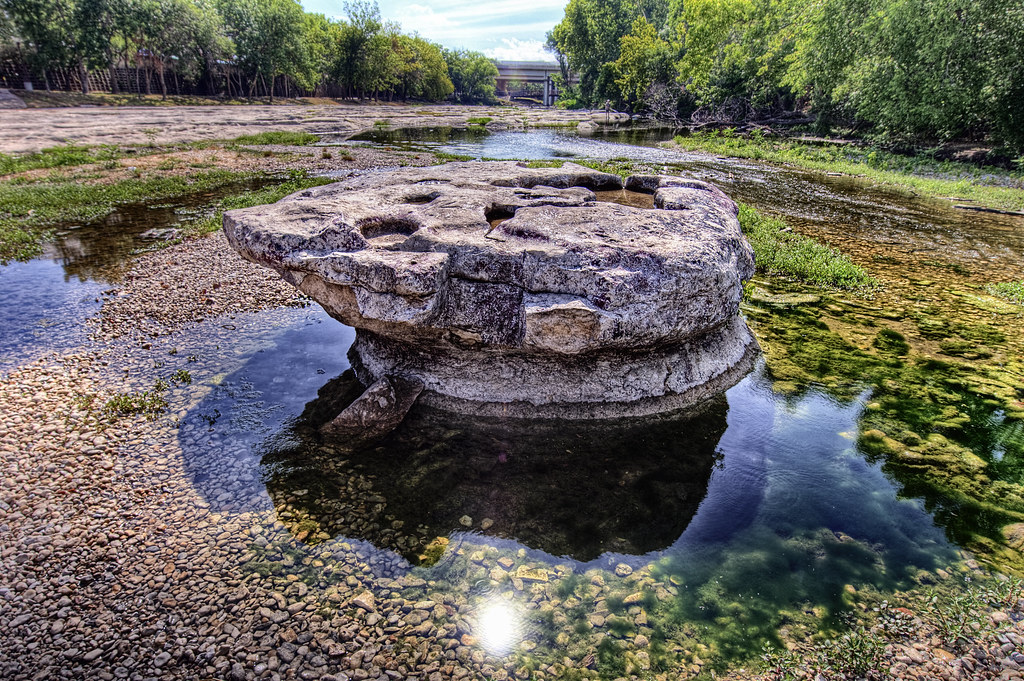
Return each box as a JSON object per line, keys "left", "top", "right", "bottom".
{"left": 224, "top": 162, "right": 757, "bottom": 418}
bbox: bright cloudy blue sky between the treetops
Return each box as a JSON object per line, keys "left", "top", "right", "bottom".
{"left": 301, "top": 0, "right": 567, "bottom": 61}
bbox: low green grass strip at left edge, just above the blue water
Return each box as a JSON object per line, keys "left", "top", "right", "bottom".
{"left": 0, "top": 170, "right": 253, "bottom": 263}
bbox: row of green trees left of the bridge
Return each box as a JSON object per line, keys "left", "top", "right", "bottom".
{"left": 0, "top": 0, "right": 498, "bottom": 102}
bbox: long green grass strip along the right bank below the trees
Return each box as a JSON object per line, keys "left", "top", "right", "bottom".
{"left": 670, "top": 131, "right": 1024, "bottom": 211}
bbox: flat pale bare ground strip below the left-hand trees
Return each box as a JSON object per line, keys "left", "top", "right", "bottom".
{"left": 0, "top": 103, "right": 589, "bottom": 154}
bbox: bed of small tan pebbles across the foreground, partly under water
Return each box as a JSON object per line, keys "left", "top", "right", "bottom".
{"left": 0, "top": 123, "right": 1024, "bottom": 681}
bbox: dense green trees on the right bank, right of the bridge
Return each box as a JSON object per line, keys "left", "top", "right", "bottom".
{"left": 548, "top": 0, "right": 1024, "bottom": 153}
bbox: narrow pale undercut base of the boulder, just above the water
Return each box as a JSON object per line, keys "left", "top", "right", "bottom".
{"left": 348, "top": 317, "right": 760, "bottom": 419}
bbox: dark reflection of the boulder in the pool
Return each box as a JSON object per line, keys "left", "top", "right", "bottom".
{"left": 262, "top": 372, "right": 728, "bottom": 560}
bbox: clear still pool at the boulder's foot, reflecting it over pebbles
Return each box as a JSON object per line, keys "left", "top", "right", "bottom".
{"left": 172, "top": 303, "right": 957, "bottom": 674}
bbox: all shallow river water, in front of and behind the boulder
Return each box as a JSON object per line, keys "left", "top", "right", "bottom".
{"left": 0, "top": 125, "right": 1024, "bottom": 674}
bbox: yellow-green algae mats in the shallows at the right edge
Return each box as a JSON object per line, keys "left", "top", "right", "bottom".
{"left": 744, "top": 274, "right": 1024, "bottom": 572}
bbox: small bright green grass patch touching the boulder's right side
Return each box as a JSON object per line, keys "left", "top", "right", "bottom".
{"left": 739, "top": 205, "right": 878, "bottom": 289}
